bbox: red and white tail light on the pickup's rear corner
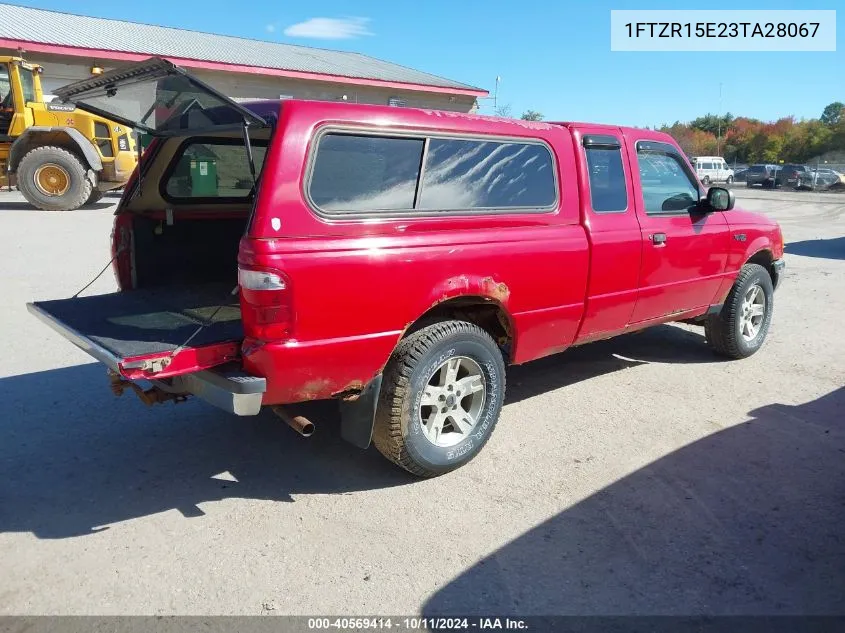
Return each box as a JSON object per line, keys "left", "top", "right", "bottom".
{"left": 238, "top": 268, "right": 293, "bottom": 341}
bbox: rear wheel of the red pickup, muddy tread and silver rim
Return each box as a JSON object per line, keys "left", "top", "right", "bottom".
{"left": 373, "top": 321, "right": 505, "bottom": 477}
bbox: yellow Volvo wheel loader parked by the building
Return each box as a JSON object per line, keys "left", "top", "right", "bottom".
{"left": 0, "top": 55, "right": 138, "bottom": 211}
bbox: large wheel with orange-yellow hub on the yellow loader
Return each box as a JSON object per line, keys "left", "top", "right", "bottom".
{"left": 17, "top": 146, "right": 92, "bottom": 211}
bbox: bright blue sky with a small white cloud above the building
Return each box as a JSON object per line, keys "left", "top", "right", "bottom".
{"left": 12, "top": 0, "right": 845, "bottom": 126}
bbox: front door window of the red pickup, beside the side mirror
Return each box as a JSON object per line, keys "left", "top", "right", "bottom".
{"left": 637, "top": 142, "right": 699, "bottom": 215}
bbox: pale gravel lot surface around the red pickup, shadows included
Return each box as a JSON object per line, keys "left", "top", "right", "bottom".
{"left": 0, "top": 189, "right": 845, "bottom": 615}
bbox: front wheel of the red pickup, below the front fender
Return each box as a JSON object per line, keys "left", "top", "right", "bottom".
{"left": 704, "top": 264, "right": 774, "bottom": 359}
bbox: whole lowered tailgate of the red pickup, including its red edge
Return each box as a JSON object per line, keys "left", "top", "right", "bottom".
{"left": 27, "top": 284, "right": 243, "bottom": 380}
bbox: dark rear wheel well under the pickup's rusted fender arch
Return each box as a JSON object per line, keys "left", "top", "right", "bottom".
{"left": 404, "top": 297, "right": 514, "bottom": 362}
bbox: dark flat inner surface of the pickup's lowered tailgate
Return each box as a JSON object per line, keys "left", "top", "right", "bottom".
{"left": 32, "top": 283, "right": 243, "bottom": 358}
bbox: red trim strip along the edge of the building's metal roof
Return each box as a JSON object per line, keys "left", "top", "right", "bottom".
{"left": 0, "top": 38, "right": 490, "bottom": 98}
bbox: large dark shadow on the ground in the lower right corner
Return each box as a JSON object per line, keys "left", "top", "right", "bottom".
{"left": 423, "top": 388, "right": 845, "bottom": 616}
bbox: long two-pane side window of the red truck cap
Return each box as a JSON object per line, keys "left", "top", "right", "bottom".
{"left": 305, "top": 130, "right": 558, "bottom": 217}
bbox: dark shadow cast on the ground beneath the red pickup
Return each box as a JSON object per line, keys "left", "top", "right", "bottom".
{"left": 0, "top": 326, "right": 715, "bottom": 538}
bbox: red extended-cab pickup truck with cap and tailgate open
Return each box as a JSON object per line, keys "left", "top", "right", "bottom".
{"left": 29, "top": 59, "right": 783, "bottom": 476}
